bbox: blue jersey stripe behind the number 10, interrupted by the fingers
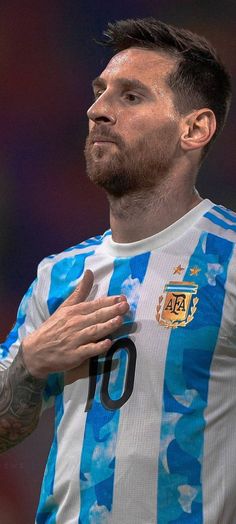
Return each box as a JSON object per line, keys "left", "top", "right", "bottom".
{"left": 79, "top": 253, "right": 150, "bottom": 524}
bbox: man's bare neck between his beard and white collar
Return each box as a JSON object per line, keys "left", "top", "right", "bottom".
{"left": 108, "top": 177, "right": 202, "bottom": 243}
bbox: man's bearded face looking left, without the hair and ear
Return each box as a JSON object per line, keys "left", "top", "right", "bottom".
{"left": 85, "top": 48, "right": 183, "bottom": 197}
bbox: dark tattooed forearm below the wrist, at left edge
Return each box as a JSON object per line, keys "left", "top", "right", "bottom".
{"left": 0, "top": 347, "right": 46, "bottom": 453}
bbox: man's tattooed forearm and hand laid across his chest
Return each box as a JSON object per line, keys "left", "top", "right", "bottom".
{"left": 0, "top": 271, "right": 129, "bottom": 452}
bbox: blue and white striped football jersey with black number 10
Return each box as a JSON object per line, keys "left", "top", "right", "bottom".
{"left": 1, "top": 200, "right": 236, "bottom": 524}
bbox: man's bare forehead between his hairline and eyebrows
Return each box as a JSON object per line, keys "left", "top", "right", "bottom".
{"left": 100, "top": 47, "right": 176, "bottom": 83}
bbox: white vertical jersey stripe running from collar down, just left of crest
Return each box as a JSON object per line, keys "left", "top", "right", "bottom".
{"left": 111, "top": 230, "right": 199, "bottom": 524}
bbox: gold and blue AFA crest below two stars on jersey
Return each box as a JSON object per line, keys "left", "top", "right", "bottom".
{"left": 156, "top": 282, "right": 199, "bottom": 328}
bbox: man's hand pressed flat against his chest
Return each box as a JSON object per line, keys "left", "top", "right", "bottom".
{"left": 22, "top": 270, "right": 129, "bottom": 378}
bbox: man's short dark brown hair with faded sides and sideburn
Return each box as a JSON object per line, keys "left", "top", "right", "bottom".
{"left": 98, "top": 17, "right": 231, "bottom": 152}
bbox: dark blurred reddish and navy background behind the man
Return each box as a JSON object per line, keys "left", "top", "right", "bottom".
{"left": 0, "top": 0, "right": 236, "bottom": 524}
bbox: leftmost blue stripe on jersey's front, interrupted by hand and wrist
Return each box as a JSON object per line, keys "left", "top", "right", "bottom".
{"left": 36, "top": 251, "right": 94, "bottom": 524}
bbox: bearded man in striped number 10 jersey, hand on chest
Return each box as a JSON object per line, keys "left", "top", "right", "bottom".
{"left": 1, "top": 19, "right": 236, "bottom": 524}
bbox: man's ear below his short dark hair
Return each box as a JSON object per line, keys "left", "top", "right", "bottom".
{"left": 180, "top": 108, "right": 216, "bottom": 151}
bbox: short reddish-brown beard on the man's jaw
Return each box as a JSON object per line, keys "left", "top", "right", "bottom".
{"left": 85, "top": 124, "right": 179, "bottom": 198}
